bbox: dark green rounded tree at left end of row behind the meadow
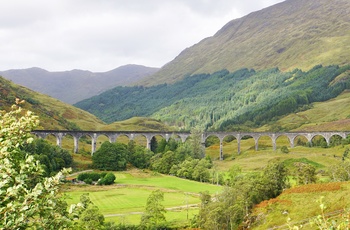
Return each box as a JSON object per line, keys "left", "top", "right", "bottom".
{"left": 92, "top": 141, "right": 128, "bottom": 171}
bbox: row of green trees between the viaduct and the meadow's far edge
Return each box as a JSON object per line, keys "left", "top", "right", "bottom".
{"left": 92, "top": 129, "right": 216, "bottom": 182}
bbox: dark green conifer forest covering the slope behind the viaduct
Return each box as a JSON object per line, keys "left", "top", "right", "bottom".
{"left": 76, "top": 65, "right": 350, "bottom": 130}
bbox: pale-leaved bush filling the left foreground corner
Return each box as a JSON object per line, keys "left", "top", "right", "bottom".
{"left": 0, "top": 102, "right": 106, "bottom": 229}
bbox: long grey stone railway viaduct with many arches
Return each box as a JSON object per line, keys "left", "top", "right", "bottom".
{"left": 32, "top": 130, "right": 350, "bottom": 160}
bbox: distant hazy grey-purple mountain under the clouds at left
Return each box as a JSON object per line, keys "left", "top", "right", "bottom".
{"left": 0, "top": 65, "right": 158, "bottom": 104}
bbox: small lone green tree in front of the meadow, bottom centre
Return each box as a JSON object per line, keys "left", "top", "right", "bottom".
{"left": 140, "top": 189, "right": 166, "bottom": 229}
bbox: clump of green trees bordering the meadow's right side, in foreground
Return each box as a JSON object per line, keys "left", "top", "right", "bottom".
{"left": 197, "top": 162, "right": 288, "bottom": 229}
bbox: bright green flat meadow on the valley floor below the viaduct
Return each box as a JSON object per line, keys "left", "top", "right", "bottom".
{"left": 64, "top": 169, "right": 222, "bottom": 224}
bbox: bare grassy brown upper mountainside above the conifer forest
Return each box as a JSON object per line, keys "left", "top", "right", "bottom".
{"left": 138, "top": 0, "right": 350, "bottom": 85}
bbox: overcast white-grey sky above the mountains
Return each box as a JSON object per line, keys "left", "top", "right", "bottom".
{"left": 0, "top": 0, "right": 283, "bottom": 72}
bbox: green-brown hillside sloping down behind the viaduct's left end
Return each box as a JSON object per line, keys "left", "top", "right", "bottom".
{"left": 0, "top": 76, "right": 175, "bottom": 131}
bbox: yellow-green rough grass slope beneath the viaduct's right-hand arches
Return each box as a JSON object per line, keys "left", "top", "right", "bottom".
{"left": 206, "top": 137, "right": 350, "bottom": 172}
